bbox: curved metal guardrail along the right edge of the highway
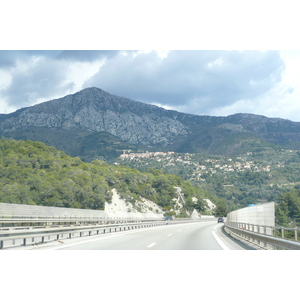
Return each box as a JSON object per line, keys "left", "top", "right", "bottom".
{"left": 224, "top": 222, "right": 300, "bottom": 250}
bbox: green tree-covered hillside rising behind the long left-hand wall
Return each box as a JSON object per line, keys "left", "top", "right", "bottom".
{"left": 0, "top": 139, "right": 216, "bottom": 216}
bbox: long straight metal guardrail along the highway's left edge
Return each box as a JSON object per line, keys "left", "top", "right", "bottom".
{"left": 0, "top": 219, "right": 200, "bottom": 249}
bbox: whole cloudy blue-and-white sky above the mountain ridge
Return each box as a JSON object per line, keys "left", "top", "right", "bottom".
{"left": 0, "top": 50, "right": 300, "bottom": 121}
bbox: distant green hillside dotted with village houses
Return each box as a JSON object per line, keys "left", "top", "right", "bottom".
{"left": 116, "top": 148, "right": 300, "bottom": 209}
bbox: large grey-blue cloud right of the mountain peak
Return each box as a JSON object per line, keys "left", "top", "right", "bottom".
{"left": 85, "top": 51, "right": 284, "bottom": 114}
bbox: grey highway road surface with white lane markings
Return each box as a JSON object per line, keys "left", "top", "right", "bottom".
{"left": 36, "top": 221, "right": 245, "bottom": 250}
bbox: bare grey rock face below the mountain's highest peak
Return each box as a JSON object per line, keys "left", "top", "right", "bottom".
{"left": 1, "top": 88, "right": 187, "bottom": 145}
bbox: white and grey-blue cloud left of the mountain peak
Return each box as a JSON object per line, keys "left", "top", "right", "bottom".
{"left": 0, "top": 52, "right": 105, "bottom": 113}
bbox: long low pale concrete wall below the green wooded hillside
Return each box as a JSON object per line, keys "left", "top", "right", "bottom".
{"left": 0, "top": 203, "right": 163, "bottom": 219}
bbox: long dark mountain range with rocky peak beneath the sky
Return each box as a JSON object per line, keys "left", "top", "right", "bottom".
{"left": 0, "top": 87, "right": 300, "bottom": 161}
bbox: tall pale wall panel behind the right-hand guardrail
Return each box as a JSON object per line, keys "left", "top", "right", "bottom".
{"left": 227, "top": 202, "right": 275, "bottom": 226}
